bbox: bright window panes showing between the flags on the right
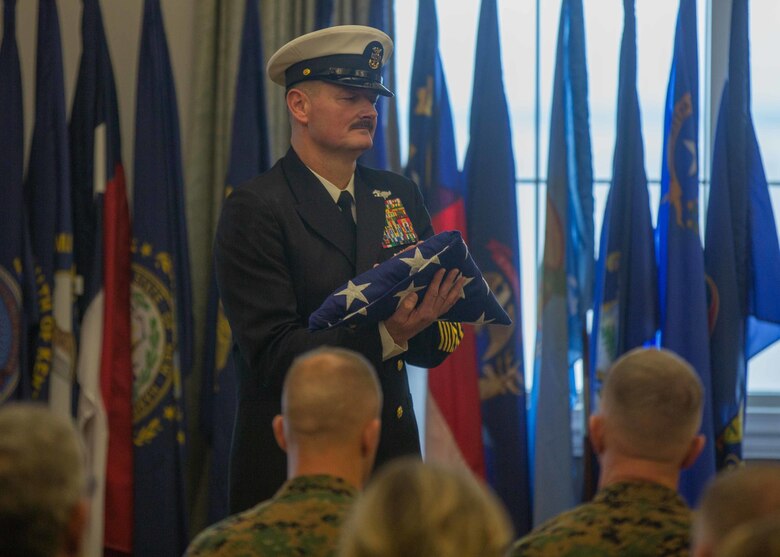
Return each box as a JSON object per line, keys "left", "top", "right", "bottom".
{"left": 395, "top": 0, "right": 780, "bottom": 406}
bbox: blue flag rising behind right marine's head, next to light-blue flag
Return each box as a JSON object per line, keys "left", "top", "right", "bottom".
{"left": 589, "top": 0, "right": 658, "bottom": 411}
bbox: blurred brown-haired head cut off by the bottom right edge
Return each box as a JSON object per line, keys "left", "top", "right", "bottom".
{"left": 693, "top": 464, "right": 780, "bottom": 555}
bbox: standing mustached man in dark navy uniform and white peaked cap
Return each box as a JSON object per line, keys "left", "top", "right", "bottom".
{"left": 214, "top": 25, "right": 464, "bottom": 513}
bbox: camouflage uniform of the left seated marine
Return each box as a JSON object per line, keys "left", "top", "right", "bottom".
{"left": 186, "top": 475, "right": 357, "bottom": 557}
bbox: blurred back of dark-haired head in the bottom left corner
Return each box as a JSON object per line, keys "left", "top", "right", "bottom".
{"left": 0, "top": 403, "right": 86, "bottom": 557}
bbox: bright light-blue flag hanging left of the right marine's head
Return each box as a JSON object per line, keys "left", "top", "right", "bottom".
{"left": 530, "top": 0, "right": 594, "bottom": 524}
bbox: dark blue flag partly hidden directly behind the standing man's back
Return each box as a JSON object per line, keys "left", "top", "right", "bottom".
{"left": 200, "top": 0, "right": 271, "bottom": 524}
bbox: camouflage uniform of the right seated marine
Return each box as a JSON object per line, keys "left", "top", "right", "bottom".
{"left": 512, "top": 481, "right": 692, "bottom": 557}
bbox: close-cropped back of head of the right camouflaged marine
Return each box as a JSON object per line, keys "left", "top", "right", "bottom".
{"left": 600, "top": 348, "right": 703, "bottom": 462}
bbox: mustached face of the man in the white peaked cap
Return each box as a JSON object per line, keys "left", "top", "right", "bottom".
{"left": 308, "top": 81, "right": 377, "bottom": 157}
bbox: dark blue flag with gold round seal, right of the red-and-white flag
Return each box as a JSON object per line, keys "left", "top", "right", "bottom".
{"left": 131, "top": 0, "right": 192, "bottom": 556}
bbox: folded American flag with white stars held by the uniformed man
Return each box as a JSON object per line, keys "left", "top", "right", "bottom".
{"left": 309, "top": 231, "right": 512, "bottom": 331}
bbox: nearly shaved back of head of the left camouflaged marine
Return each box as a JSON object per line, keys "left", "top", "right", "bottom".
{"left": 282, "top": 347, "right": 382, "bottom": 450}
